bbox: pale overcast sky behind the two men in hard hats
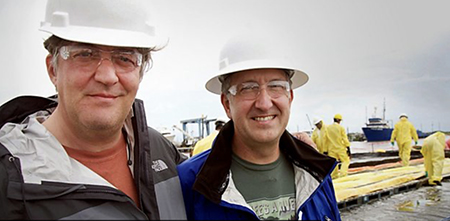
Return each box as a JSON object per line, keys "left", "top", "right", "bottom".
{"left": 0, "top": 0, "right": 450, "bottom": 142}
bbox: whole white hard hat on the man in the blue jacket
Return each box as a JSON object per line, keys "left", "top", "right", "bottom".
{"left": 205, "top": 34, "right": 308, "bottom": 94}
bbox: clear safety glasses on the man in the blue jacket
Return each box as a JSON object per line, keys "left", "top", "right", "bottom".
{"left": 228, "top": 80, "right": 291, "bottom": 100}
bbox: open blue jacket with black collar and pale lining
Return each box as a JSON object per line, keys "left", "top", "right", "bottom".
{"left": 177, "top": 121, "right": 341, "bottom": 220}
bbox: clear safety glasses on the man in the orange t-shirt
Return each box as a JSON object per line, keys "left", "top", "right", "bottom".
{"left": 59, "top": 45, "right": 142, "bottom": 73}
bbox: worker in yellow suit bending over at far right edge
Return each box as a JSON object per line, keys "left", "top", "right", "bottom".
{"left": 420, "top": 132, "right": 446, "bottom": 186}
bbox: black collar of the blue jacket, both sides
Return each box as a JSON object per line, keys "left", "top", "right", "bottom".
{"left": 193, "top": 120, "right": 335, "bottom": 203}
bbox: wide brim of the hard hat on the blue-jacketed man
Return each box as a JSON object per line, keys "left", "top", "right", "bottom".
{"left": 205, "top": 60, "right": 309, "bottom": 95}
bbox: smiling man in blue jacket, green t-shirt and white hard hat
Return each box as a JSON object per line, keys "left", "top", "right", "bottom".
{"left": 178, "top": 32, "right": 340, "bottom": 220}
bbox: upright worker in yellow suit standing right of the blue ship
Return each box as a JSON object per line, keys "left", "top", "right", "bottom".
{"left": 391, "top": 113, "right": 419, "bottom": 166}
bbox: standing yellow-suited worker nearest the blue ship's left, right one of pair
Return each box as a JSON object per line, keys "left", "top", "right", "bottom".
{"left": 327, "top": 114, "right": 351, "bottom": 179}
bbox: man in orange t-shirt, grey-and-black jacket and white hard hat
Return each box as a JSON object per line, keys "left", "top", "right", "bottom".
{"left": 0, "top": 0, "right": 186, "bottom": 220}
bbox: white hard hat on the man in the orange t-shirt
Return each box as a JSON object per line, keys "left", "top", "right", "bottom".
{"left": 39, "top": 0, "right": 166, "bottom": 48}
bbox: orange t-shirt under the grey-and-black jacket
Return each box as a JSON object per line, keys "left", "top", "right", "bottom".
{"left": 64, "top": 139, "right": 139, "bottom": 205}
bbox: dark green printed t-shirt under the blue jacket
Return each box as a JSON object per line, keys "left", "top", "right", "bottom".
{"left": 231, "top": 154, "right": 296, "bottom": 220}
